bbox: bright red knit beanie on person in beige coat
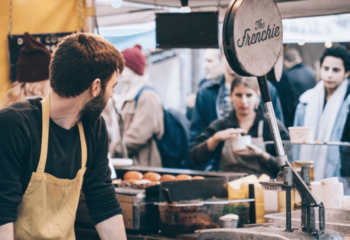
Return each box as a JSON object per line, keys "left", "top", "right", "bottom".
{"left": 122, "top": 44, "right": 146, "bottom": 75}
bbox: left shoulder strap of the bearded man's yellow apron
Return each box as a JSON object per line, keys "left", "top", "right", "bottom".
{"left": 36, "top": 94, "right": 50, "bottom": 172}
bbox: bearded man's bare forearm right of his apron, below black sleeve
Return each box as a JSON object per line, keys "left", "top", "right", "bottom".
{"left": 95, "top": 214, "right": 126, "bottom": 240}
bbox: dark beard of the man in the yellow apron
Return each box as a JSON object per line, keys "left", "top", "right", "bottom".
{"left": 79, "top": 89, "right": 107, "bottom": 122}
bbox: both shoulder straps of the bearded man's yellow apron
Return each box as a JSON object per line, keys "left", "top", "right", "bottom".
{"left": 36, "top": 94, "right": 87, "bottom": 172}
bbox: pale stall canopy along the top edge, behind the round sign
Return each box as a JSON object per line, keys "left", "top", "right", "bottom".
{"left": 96, "top": 0, "right": 350, "bottom": 27}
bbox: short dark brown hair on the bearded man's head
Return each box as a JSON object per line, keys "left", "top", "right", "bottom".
{"left": 50, "top": 33, "right": 124, "bottom": 98}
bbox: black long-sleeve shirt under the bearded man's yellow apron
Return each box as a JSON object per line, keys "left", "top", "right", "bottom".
{"left": 0, "top": 98, "right": 122, "bottom": 225}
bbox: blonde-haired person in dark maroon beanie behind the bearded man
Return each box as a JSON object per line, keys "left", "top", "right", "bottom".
{"left": 3, "top": 32, "right": 51, "bottom": 107}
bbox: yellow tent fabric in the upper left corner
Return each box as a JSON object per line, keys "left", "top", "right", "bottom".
{"left": 0, "top": 0, "right": 84, "bottom": 103}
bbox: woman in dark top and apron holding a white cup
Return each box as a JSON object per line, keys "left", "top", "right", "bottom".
{"left": 190, "top": 77, "right": 289, "bottom": 177}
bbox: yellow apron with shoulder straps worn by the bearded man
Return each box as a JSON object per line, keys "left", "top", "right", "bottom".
{"left": 14, "top": 95, "right": 87, "bottom": 240}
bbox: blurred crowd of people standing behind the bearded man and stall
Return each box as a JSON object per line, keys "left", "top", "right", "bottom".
{"left": 4, "top": 34, "right": 350, "bottom": 180}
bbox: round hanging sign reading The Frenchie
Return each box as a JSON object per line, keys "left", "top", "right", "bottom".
{"left": 223, "top": 0, "right": 282, "bottom": 76}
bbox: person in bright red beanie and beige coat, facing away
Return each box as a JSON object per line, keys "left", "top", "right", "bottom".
{"left": 113, "top": 45, "right": 164, "bottom": 167}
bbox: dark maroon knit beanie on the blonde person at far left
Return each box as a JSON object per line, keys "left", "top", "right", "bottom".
{"left": 17, "top": 32, "right": 51, "bottom": 82}
